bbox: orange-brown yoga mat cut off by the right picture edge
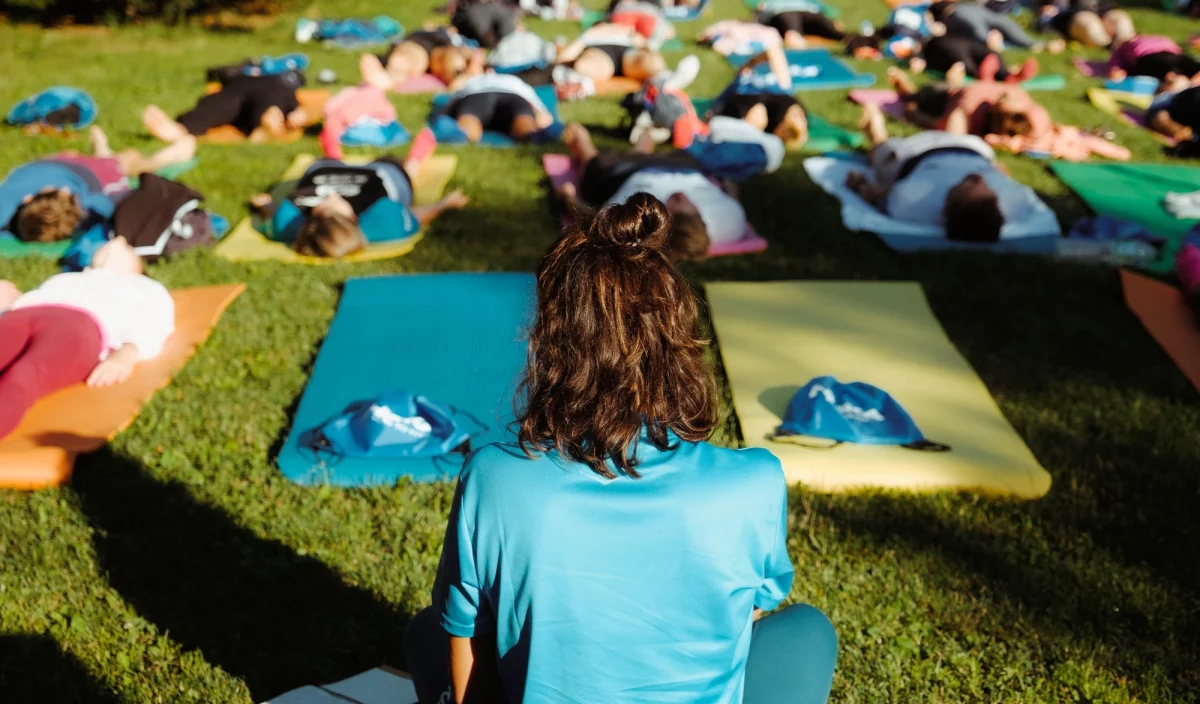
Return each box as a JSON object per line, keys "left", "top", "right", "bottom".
{"left": 1121, "top": 269, "right": 1200, "bottom": 391}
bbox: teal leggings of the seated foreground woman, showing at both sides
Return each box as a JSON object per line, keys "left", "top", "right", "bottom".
{"left": 404, "top": 603, "right": 838, "bottom": 704}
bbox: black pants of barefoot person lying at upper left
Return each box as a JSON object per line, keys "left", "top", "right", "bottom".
{"left": 176, "top": 76, "right": 300, "bottom": 137}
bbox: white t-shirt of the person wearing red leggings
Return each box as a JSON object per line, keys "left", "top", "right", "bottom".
{"left": 7, "top": 269, "right": 175, "bottom": 360}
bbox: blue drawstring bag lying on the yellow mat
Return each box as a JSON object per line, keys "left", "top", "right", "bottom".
{"left": 770, "top": 377, "right": 949, "bottom": 452}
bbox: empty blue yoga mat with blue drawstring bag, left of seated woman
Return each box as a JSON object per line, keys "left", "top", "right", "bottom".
{"left": 278, "top": 273, "right": 534, "bottom": 487}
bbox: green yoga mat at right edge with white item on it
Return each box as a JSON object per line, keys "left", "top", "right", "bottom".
{"left": 1050, "top": 162, "right": 1200, "bottom": 273}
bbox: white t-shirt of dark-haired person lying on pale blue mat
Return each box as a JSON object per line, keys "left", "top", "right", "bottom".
{"left": 887, "top": 151, "right": 1038, "bottom": 225}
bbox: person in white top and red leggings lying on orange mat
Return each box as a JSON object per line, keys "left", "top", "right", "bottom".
{"left": 0, "top": 237, "right": 175, "bottom": 438}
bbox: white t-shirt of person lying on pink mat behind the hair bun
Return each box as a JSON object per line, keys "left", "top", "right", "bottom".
{"left": 608, "top": 169, "right": 746, "bottom": 245}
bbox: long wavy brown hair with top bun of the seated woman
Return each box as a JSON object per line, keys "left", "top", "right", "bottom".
{"left": 517, "top": 193, "right": 716, "bottom": 479}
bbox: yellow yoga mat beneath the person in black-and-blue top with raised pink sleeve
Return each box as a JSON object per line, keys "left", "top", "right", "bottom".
{"left": 215, "top": 154, "right": 458, "bottom": 264}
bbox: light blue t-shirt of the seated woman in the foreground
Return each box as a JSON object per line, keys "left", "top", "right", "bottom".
{"left": 433, "top": 435, "right": 792, "bottom": 704}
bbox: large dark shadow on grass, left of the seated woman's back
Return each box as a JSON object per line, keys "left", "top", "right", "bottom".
{"left": 73, "top": 450, "right": 417, "bottom": 702}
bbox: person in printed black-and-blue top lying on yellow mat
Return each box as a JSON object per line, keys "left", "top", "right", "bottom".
{"left": 250, "top": 130, "right": 468, "bottom": 258}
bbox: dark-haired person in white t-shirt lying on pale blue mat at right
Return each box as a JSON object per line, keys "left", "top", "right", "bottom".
{"left": 846, "top": 106, "right": 1038, "bottom": 242}
